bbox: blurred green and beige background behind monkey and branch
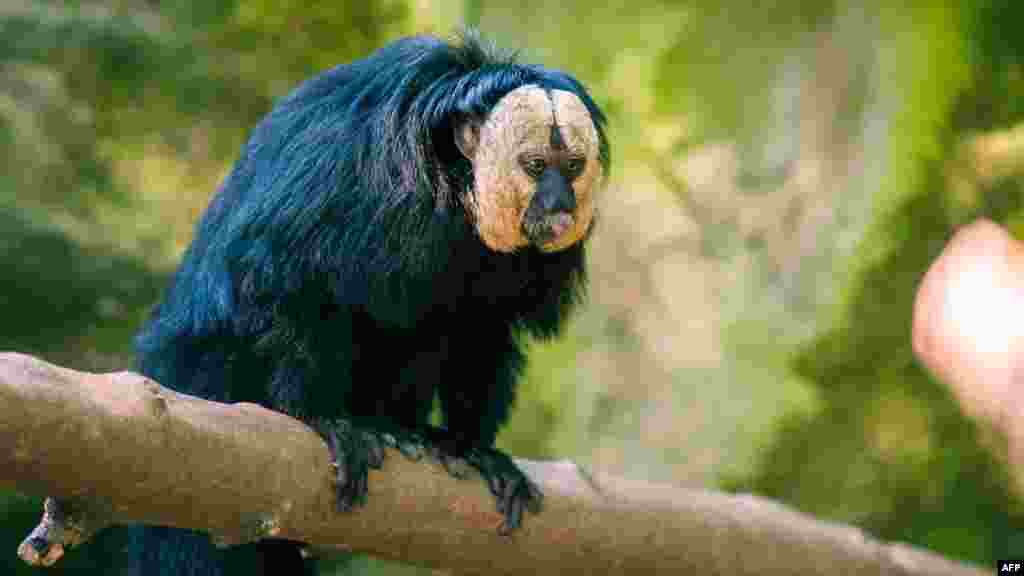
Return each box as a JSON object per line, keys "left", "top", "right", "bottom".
{"left": 0, "top": 0, "right": 1024, "bottom": 574}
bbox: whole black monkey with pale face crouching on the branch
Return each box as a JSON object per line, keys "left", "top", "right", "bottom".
{"left": 119, "top": 30, "right": 610, "bottom": 575}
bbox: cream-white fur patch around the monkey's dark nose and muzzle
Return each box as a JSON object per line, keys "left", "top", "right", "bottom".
{"left": 456, "top": 85, "right": 603, "bottom": 252}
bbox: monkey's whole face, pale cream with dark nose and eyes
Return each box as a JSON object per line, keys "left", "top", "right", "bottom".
{"left": 456, "top": 85, "right": 603, "bottom": 252}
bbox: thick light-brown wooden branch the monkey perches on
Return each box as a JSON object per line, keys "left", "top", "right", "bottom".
{"left": 0, "top": 354, "right": 983, "bottom": 576}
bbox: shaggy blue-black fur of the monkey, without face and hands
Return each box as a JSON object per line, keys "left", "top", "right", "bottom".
{"left": 124, "top": 34, "right": 608, "bottom": 575}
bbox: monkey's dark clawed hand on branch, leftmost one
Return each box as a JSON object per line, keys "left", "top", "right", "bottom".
{"left": 315, "top": 419, "right": 387, "bottom": 511}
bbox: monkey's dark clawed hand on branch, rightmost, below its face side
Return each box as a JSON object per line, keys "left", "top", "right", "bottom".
{"left": 466, "top": 448, "right": 544, "bottom": 534}
